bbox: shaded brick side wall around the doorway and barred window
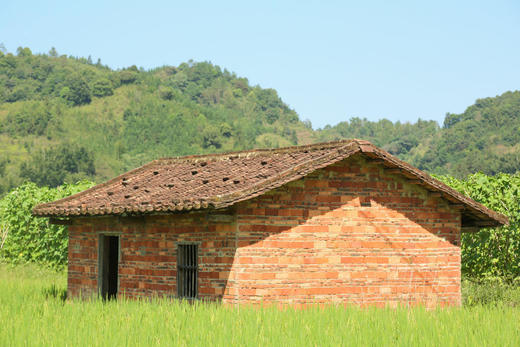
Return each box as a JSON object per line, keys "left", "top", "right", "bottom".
{"left": 68, "top": 213, "right": 235, "bottom": 300}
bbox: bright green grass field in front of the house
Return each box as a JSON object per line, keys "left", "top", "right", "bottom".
{"left": 0, "top": 264, "right": 520, "bottom": 347}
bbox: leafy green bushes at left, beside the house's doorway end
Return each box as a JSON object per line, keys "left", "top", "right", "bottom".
{"left": 0, "top": 181, "right": 93, "bottom": 268}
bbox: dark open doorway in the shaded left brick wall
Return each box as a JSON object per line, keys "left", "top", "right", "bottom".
{"left": 99, "top": 235, "right": 119, "bottom": 300}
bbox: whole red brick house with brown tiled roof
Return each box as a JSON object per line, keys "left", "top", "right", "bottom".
{"left": 33, "top": 140, "right": 507, "bottom": 306}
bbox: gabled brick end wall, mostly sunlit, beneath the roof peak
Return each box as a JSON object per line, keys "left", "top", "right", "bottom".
{"left": 234, "top": 156, "right": 460, "bottom": 305}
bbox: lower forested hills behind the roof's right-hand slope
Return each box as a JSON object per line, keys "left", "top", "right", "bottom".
{"left": 317, "top": 91, "right": 520, "bottom": 177}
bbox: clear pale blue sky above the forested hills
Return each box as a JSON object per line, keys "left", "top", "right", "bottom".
{"left": 0, "top": 0, "right": 520, "bottom": 128}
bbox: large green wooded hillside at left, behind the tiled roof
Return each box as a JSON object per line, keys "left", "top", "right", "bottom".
{"left": 0, "top": 48, "right": 311, "bottom": 191}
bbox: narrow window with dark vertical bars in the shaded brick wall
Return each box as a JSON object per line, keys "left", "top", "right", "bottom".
{"left": 177, "top": 244, "right": 199, "bottom": 299}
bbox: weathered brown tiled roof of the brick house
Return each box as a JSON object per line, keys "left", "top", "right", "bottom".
{"left": 33, "top": 140, "right": 507, "bottom": 226}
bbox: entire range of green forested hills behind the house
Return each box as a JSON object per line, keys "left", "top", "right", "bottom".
{"left": 0, "top": 48, "right": 520, "bottom": 194}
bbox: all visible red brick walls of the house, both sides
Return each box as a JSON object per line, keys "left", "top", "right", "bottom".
{"left": 68, "top": 156, "right": 460, "bottom": 305}
